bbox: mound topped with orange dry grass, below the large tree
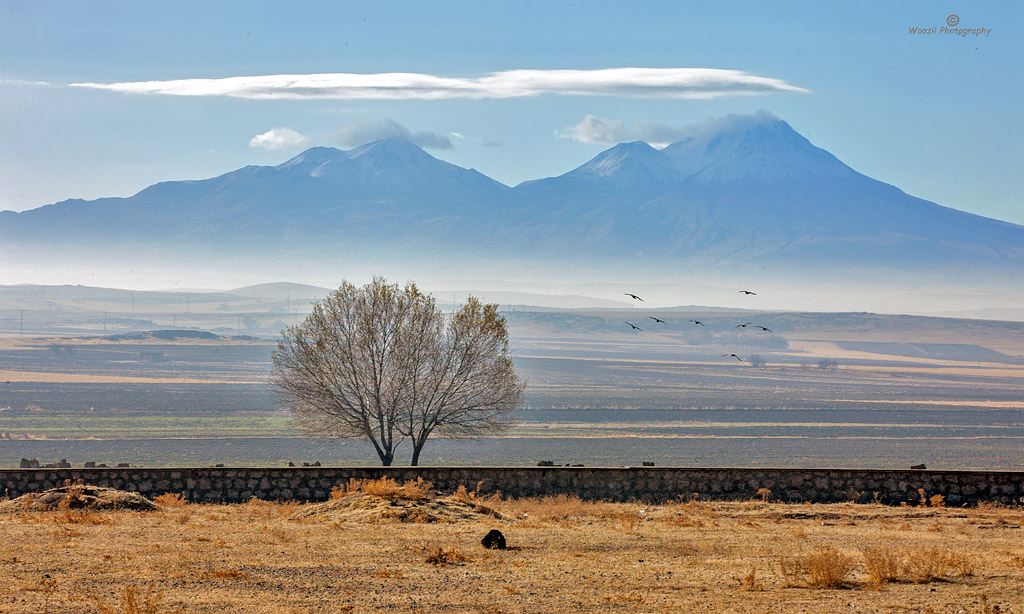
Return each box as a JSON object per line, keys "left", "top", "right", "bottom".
{"left": 289, "top": 492, "right": 502, "bottom": 523}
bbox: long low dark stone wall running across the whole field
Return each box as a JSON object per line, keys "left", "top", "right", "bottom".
{"left": 0, "top": 467, "right": 1024, "bottom": 506}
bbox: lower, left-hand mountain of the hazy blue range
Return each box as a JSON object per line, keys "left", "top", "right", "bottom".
{"left": 0, "top": 139, "right": 509, "bottom": 247}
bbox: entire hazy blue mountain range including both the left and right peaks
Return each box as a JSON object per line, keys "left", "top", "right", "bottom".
{"left": 0, "top": 113, "right": 1024, "bottom": 292}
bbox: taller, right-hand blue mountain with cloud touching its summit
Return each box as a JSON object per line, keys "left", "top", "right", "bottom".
{"left": 499, "top": 114, "right": 1024, "bottom": 269}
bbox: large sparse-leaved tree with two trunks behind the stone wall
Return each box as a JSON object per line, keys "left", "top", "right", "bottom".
{"left": 270, "top": 277, "right": 523, "bottom": 466}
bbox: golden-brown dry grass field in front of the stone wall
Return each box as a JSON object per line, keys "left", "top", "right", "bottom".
{"left": 0, "top": 497, "right": 1024, "bottom": 614}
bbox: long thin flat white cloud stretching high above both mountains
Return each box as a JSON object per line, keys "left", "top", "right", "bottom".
{"left": 71, "top": 68, "right": 807, "bottom": 100}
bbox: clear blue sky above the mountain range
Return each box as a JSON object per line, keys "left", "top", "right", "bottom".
{"left": 0, "top": 0, "right": 1024, "bottom": 223}
